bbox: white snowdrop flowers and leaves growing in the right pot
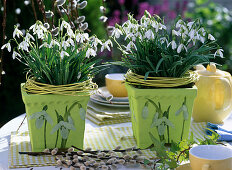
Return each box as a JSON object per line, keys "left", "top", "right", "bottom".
{"left": 111, "top": 11, "right": 223, "bottom": 78}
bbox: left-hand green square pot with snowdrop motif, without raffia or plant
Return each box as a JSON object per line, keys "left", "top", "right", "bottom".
{"left": 21, "top": 84, "right": 89, "bottom": 152}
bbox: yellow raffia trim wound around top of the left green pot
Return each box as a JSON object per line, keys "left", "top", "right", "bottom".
{"left": 25, "top": 78, "right": 98, "bottom": 96}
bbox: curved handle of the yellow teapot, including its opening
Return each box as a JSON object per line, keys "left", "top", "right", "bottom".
{"left": 214, "top": 78, "right": 232, "bottom": 110}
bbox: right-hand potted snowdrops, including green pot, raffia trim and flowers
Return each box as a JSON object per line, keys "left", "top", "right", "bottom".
{"left": 111, "top": 11, "right": 223, "bottom": 148}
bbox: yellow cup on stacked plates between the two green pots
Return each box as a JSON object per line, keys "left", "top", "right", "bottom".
{"left": 105, "top": 73, "right": 128, "bottom": 97}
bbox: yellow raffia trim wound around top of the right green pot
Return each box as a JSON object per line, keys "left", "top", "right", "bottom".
{"left": 125, "top": 70, "right": 198, "bottom": 87}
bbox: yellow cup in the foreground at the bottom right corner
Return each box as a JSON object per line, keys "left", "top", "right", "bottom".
{"left": 189, "top": 145, "right": 232, "bottom": 170}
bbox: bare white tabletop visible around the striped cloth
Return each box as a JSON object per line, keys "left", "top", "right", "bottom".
{"left": 0, "top": 114, "right": 232, "bottom": 170}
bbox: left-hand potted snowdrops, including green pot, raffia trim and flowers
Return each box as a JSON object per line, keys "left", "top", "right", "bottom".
{"left": 2, "top": 20, "right": 112, "bottom": 151}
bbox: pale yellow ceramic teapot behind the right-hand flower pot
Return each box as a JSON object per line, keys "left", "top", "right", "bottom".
{"left": 192, "top": 64, "right": 232, "bottom": 124}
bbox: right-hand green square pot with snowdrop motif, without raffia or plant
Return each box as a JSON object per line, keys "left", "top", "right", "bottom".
{"left": 126, "top": 83, "right": 197, "bottom": 149}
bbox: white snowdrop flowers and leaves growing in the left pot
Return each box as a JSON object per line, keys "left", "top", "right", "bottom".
{"left": 2, "top": 20, "right": 112, "bottom": 85}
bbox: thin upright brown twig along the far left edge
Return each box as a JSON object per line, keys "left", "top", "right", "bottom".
{"left": 0, "top": 0, "right": 6, "bottom": 85}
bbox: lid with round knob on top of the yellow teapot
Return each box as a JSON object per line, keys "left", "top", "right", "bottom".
{"left": 196, "top": 63, "right": 230, "bottom": 77}
